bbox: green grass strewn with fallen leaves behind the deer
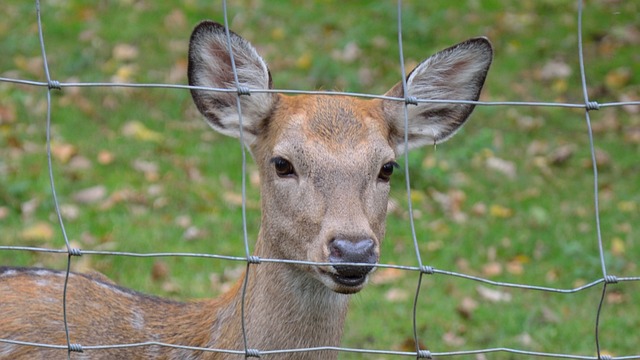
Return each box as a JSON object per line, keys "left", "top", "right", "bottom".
{"left": 0, "top": 0, "right": 640, "bottom": 359}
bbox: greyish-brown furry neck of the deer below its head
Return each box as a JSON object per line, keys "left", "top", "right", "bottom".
{"left": 212, "top": 232, "right": 349, "bottom": 359}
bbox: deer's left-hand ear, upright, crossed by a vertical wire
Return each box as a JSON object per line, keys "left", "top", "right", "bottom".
{"left": 188, "top": 21, "right": 278, "bottom": 145}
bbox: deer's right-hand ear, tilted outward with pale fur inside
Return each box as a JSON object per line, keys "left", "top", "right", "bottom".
{"left": 382, "top": 38, "right": 493, "bottom": 154}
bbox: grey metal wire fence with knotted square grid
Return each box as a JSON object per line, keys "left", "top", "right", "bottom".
{"left": 0, "top": 0, "right": 640, "bottom": 359}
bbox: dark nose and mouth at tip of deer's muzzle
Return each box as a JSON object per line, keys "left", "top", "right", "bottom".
{"left": 329, "top": 239, "right": 378, "bottom": 283}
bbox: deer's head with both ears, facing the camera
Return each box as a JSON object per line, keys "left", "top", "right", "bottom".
{"left": 189, "top": 21, "right": 492, "bottom": 293}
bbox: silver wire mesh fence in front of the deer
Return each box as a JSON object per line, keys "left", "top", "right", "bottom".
{"left": 0, "top": 0, "right": 640, "bottom": 359}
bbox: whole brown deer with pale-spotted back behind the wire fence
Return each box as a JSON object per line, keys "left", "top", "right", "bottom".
{"left": 0, "top": 20, "right": 493, "bottom": 359}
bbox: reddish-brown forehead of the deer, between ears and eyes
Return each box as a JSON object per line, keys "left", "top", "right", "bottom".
{"left": 268, "top": 96, "right": 394, "bottom": 160}
